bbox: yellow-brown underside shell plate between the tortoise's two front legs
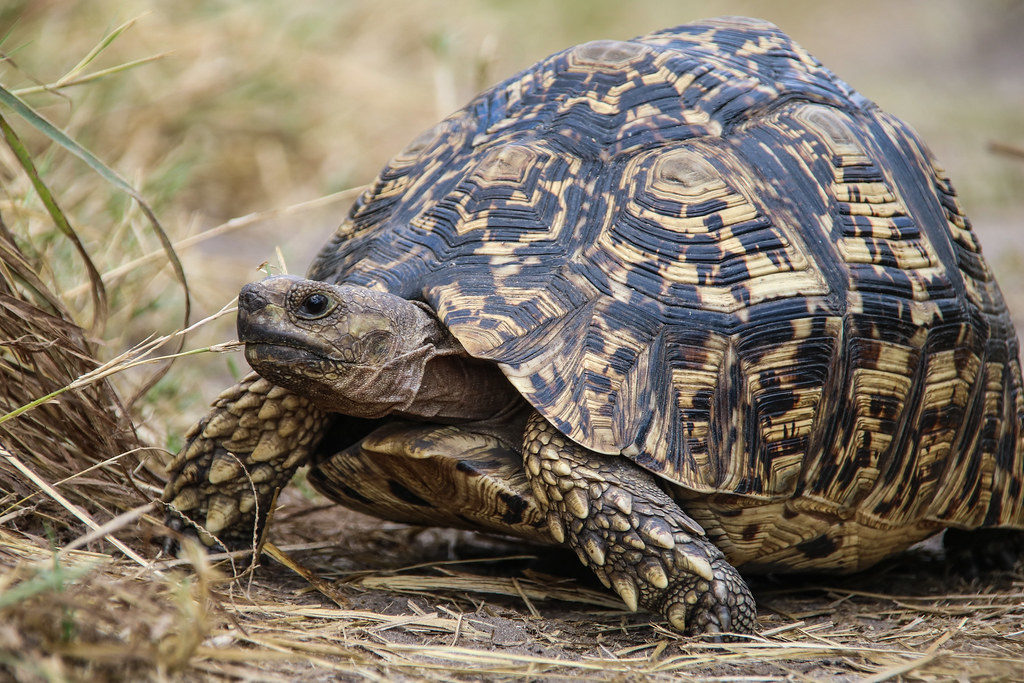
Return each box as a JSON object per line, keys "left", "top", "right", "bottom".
{"left": 309, "top": 422, "right": 552, "bottom": 544}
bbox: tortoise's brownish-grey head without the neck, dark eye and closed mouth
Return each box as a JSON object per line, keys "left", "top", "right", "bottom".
{"left": 238, "top": 275, "right": 449, "bottom": 418}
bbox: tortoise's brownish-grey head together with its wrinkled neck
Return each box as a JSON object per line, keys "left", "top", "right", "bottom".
{"left": 238, "top": 276, "right": 525, "bottom": 424}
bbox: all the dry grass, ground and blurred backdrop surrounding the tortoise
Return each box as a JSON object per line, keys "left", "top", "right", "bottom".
{"left": 0, "top": 0, "right": 1024, "bottom": 681}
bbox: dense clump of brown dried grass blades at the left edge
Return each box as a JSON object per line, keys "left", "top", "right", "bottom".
{"left": 0, "top": 210, "right": 159, "bottom": 541}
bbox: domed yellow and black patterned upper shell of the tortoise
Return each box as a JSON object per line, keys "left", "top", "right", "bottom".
{"left": 310, "top": 18, "right": 1024, "bottom": 540}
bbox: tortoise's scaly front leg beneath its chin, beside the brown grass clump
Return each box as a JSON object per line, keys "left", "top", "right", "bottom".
{"left": 161, "top": 373, "right": 328, "bottom": 550}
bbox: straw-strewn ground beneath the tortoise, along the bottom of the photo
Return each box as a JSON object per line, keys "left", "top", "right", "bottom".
{"left": 0, "top": 508, "right": 1024, "bottom": 680}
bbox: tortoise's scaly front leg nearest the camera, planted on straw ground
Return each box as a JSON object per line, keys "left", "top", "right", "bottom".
{"left": 523, "top": 414, "right": 755, "bottom": 634}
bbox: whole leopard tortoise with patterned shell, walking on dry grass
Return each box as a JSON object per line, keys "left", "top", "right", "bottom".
{"left": 163, "top": 17, "right": 1024, "bottom": 634}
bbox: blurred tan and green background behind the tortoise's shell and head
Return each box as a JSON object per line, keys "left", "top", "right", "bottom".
{"left": 0, "top": 0, "right": 1024, "bottom": 450}
